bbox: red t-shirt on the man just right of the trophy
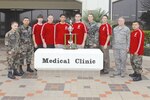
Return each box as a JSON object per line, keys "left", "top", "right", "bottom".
{"left": 72, "top": 22, "right": 87, "bottom": 45}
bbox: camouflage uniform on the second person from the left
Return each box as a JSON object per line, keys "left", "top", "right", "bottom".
{"left": 19, "top": 25, "right": 33, "bottom": 65}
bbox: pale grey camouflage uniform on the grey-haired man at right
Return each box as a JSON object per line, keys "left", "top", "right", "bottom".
{"left": 112, "top": 26, "right": 130, "bottom": 74}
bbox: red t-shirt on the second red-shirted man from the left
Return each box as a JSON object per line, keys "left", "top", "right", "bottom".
{"left": 41, "top": 23, "right": 54, "bottom": 45}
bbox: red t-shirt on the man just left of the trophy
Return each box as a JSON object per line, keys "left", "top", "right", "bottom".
{"left": 55, "top": 23, "right": 69, "bottom": 45}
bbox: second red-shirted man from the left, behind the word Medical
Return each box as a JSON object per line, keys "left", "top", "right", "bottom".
{"left": 41, "top": 15, "right": 55, "bottom": 48}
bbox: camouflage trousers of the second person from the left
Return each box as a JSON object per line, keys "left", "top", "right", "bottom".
{"left": 20, "top": 44, "right": 34, "bottom": 65}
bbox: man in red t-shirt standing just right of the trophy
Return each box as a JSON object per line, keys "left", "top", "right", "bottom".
{"left": 72, "top": 13, "right": 87, "bottom": 48}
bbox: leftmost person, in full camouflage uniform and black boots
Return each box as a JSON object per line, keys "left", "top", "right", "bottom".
{"left": 5, "top": 22, "right": 21, "bottom": 79}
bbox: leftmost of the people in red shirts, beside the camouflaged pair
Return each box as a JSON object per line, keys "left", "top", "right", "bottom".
{"left": 32, "top": 15, "right": 43, "bottom": 51}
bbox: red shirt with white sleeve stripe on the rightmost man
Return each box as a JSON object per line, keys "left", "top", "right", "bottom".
{"left": 130, "top": 29, "right": 144, "bottom": 55}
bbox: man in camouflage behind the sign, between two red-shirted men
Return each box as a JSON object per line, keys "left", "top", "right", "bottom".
{"left": 85, "top": 14, "right": 99, "bottom": 48}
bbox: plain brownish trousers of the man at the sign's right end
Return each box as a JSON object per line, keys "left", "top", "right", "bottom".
{"left": 100, "top": 46, "right": 110, "bottom": 71}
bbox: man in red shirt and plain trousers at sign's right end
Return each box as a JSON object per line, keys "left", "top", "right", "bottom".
{"left": 99, "top": 15, "right": 112, "bottom": 74}
